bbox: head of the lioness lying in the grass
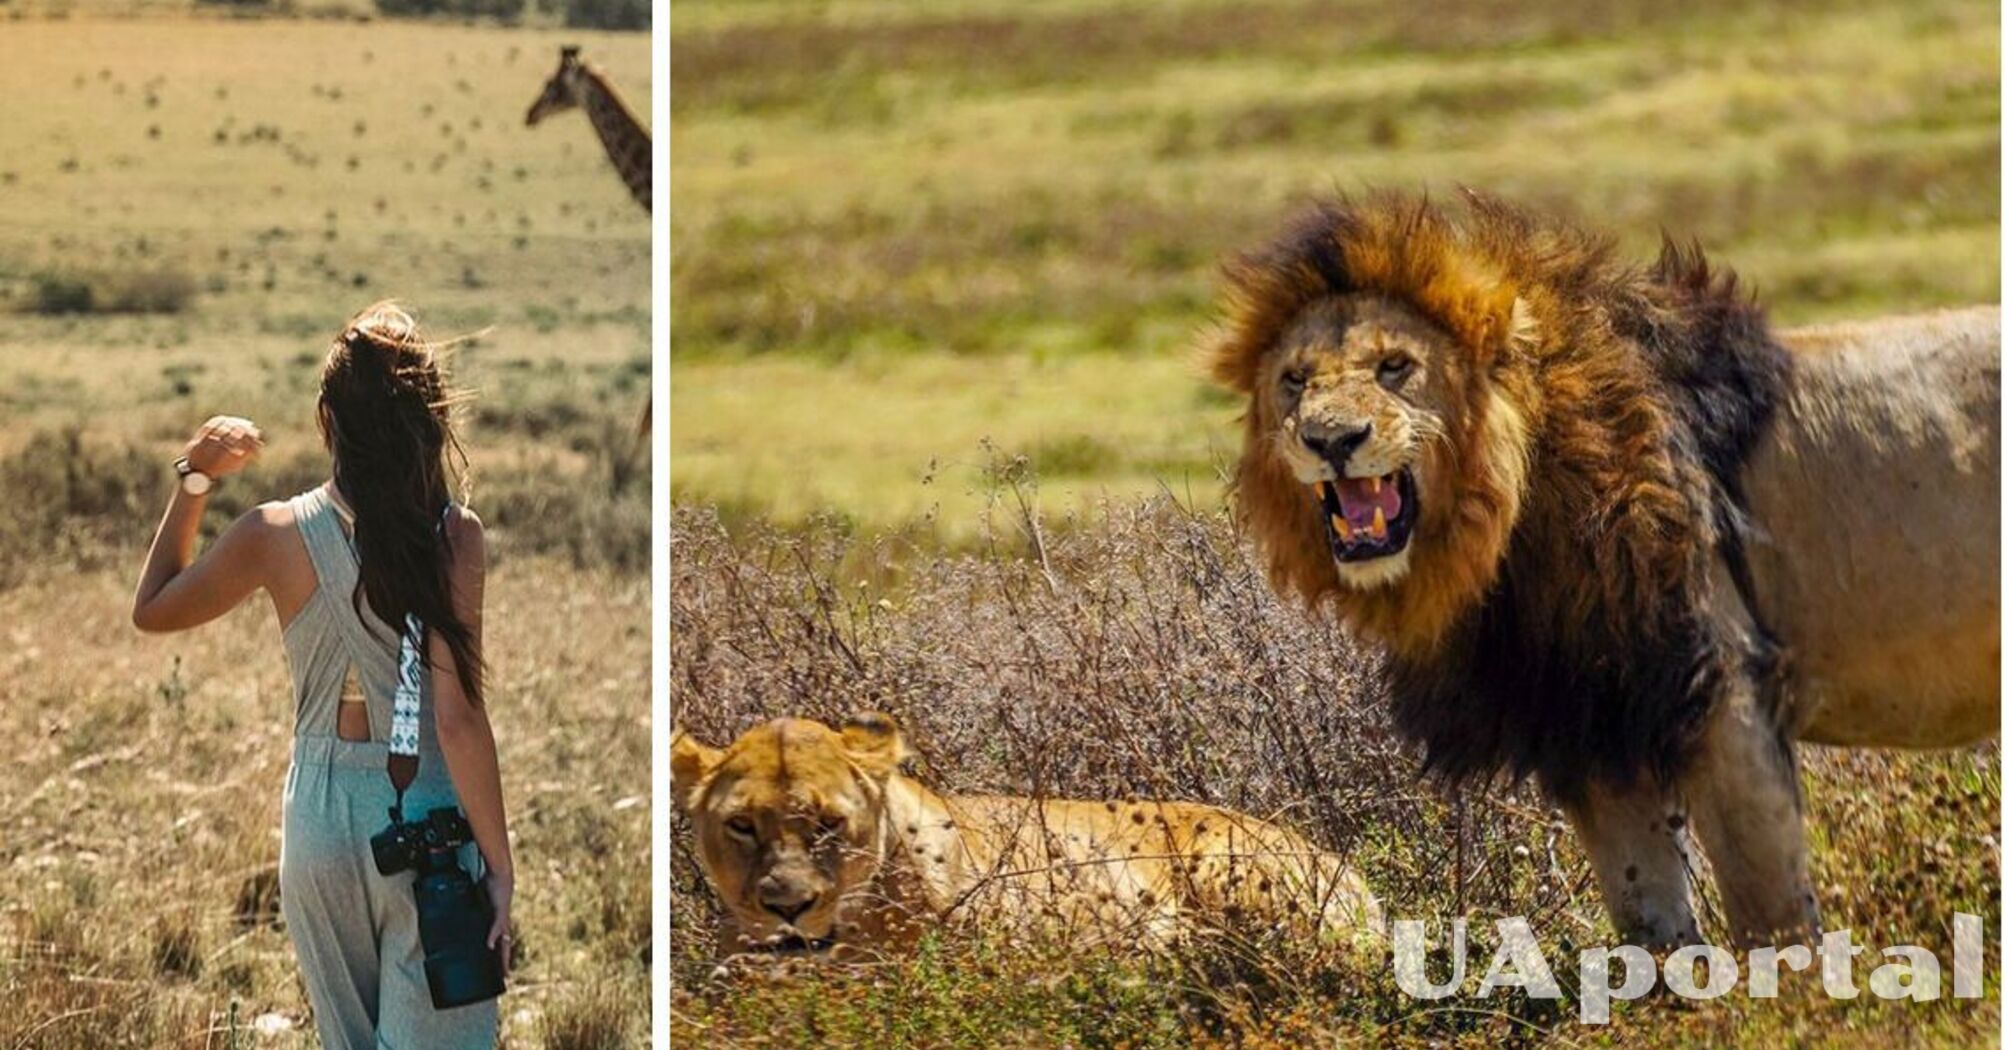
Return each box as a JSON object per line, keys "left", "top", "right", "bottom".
{"left": 669, "top": 712, "right": 905, "bottom": 951}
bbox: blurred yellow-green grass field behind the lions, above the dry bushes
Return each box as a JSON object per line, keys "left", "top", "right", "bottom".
{"left": 671, "top": 0, "right": 2000, "bottom": 537}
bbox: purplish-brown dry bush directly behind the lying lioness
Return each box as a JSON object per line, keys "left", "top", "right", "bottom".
{"left": 669, "top": 490, "right": 1586, "bottom": 949}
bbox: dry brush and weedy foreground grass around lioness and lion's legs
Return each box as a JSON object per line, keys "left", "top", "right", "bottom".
{"left": 669, "top": 486, "right": 2000, "bottom": 1048}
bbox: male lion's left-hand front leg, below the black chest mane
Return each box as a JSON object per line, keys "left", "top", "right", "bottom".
{"left": 1566, "top": 776, "right": 1702, "bottom": 949}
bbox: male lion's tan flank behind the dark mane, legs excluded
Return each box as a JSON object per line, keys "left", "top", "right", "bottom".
{"left": 1745, "top": 306, "right": 2002, "bottom": 746}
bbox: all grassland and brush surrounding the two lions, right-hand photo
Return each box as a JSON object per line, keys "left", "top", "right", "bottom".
{"left": 671, "top": 0, "right": 2002, "bottom": 1048}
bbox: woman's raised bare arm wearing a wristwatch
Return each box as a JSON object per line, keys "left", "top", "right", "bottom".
{"left": 133, "top": 416, "right": 271, "bottom": 632}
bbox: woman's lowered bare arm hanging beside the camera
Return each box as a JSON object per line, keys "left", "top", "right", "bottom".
{"left": 426, "top": 509, "right": 517, "bottom": 966}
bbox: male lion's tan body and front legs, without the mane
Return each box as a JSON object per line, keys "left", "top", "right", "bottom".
{"left": 1572, "top": 306, "right": 2002, "bottom": 943}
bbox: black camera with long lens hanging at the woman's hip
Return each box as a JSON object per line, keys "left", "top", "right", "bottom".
{"left": 370, "top": 807, "right": 503, "bottom": 1010}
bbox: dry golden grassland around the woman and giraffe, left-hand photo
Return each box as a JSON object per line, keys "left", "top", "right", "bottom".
{"left": 0, "top": 16, "right": 649, "bottom": 1048}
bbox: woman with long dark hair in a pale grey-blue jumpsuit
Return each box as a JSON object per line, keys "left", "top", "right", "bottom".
{"left": 133, "top": 302, "right": 515, "bottom": 1050}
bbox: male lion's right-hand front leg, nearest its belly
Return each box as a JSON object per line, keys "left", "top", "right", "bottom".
{"left": 1682, "top": 690, "right": 1821, "bottom": 945}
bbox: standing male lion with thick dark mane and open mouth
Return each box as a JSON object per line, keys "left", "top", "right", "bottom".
{"left": 1210, "top": 193, "right": 2000, "bottom": 945}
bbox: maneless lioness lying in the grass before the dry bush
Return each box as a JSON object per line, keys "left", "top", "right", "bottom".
{"left": 669, "top": 712, "right": 1381, "bottom": 957}
